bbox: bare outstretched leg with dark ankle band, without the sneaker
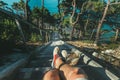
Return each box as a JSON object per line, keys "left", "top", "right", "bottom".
{"left": 55, "top": 58, "right": 87, "bottom": 80}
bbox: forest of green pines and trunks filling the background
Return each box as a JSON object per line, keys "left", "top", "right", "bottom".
{"left": 0, "top": 0, "right": 120, "bottom": 52}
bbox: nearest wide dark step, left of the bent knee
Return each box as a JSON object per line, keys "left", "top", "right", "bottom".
{"left": 16, "top": 67, "right": 50, "bottom": 80}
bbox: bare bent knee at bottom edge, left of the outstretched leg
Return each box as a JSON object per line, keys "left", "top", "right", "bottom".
{"left": 43, "top": 69, "right": 60, "bottom": 80}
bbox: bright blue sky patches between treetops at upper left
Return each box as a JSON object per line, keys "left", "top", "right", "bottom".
{"left": 2, "top": 0, "right": 58, "bottom": 13}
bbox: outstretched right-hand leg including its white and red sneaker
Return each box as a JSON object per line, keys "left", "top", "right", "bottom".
{"left": 53, "top": 47, "right": 87, "bottom": 80}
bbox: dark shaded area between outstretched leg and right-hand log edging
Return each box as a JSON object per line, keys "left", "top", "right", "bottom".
{"left": 78, "top": 55, "right": 111, "bottom": 80}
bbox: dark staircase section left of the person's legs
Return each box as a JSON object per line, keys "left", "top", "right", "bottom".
{"left": 15, "top": 46, "right": 54, "bottom": 80}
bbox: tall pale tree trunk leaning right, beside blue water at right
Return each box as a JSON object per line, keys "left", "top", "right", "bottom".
{"left": 94, "top": 0, "right": 110, "bottom": 44}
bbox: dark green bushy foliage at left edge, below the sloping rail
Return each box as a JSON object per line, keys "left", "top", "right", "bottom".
{"left": 0, "top": 13, "right": 21, "bottom": 52}
